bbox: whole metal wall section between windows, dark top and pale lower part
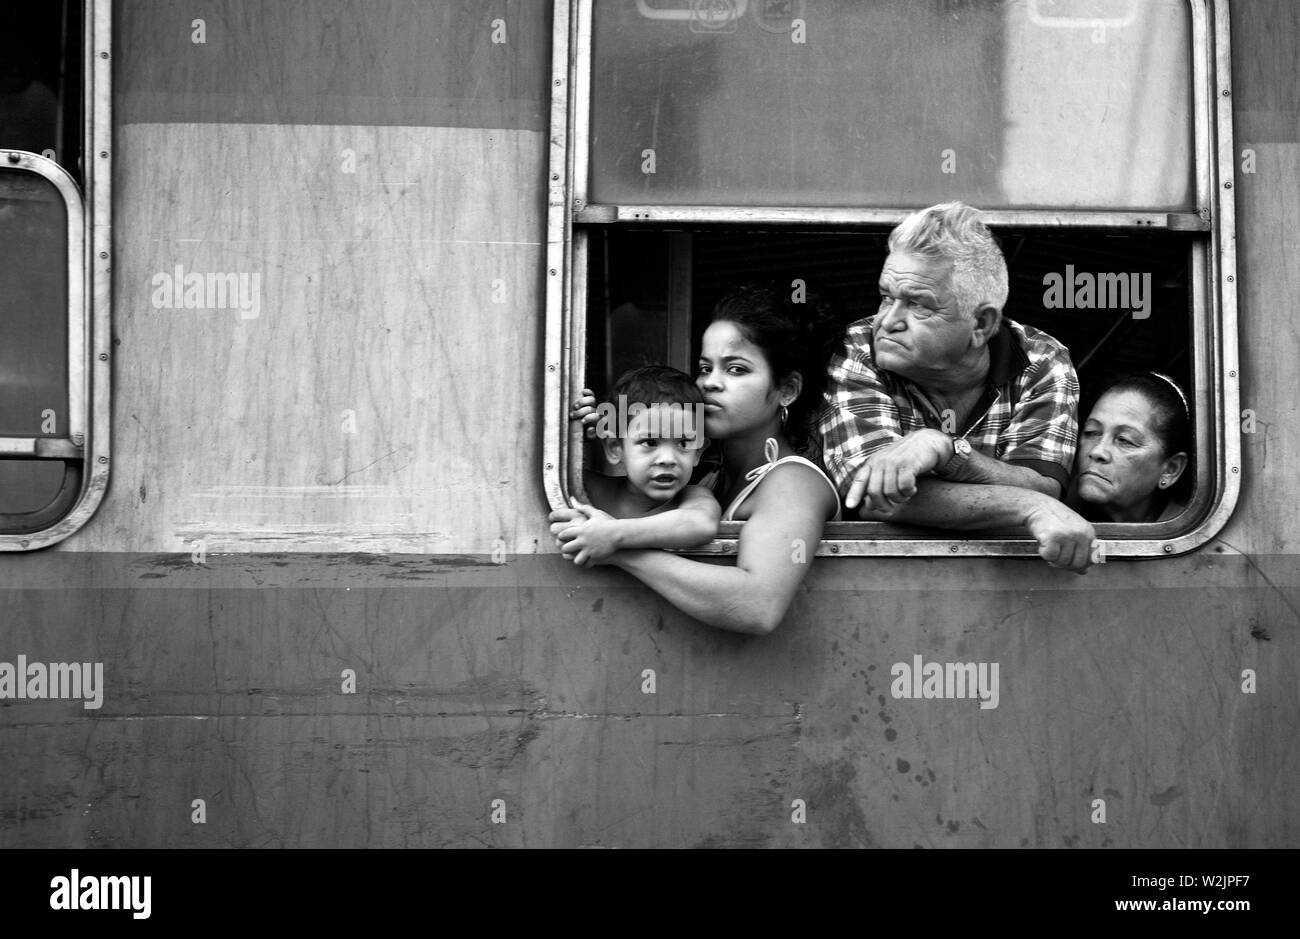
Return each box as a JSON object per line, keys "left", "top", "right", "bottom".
{"left": 64, "top": 0, "right": 550, "bottom": 553}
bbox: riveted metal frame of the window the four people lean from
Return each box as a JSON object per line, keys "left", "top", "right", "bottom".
{"left": 543, "top": 0, "right": 1242, "bottom": 559}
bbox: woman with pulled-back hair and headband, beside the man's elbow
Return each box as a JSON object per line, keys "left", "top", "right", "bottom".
{"left": 1070, "top": 372, "right": 1192, "bottom": 522}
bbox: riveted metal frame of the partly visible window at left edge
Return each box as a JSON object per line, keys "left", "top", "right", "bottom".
{"left": 0, "top": 0, "right": 113, "bottom": 551}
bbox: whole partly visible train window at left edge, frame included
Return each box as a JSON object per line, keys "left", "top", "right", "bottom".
{"left": 0, "top": 0, "right": 112, "bottom": 550}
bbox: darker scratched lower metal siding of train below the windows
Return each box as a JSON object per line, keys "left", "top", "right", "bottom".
{"left": 0, "top": 554, "right": 1300, "bottom": 847}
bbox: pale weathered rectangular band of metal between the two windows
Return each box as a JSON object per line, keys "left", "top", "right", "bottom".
{"left": 66, "top": 124, "right": 545, "bottom": 553}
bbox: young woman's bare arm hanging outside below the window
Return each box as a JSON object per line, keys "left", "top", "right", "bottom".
{"left": 608, "top": 464, "right": 835, "bottom": 635}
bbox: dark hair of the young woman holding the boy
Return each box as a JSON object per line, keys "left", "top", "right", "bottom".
{"left": 710, "top": 284, "right": 844, "bottom": 453}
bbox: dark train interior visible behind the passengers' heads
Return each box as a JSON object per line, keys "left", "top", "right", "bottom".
{"left": 586, "top": 228, "right": 1192, "bottom": 431}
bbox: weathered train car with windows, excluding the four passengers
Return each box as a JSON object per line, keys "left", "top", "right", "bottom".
{"left": 0, "top": 0, "right": 1300, "bottom": 848}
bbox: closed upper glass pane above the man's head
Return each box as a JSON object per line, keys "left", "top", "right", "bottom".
{"left": 589, "top": 0, "right": 1195, "bottom": 211}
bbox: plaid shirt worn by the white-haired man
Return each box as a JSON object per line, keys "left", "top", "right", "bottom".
{"left": 819, "top": 316, "right": 1079, "bottom": 496}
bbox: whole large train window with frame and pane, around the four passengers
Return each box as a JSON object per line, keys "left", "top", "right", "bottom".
{"left": 546, "top": 0, "right": 1239, "bottom": 557}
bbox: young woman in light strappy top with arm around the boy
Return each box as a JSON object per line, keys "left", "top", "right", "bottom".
{"left": 551, "top": 287, "right": 840, "bottom": 635}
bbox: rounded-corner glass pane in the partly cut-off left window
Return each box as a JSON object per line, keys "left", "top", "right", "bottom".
{"left": 0, "top": 168, "right": 68, "bottom": 437}
